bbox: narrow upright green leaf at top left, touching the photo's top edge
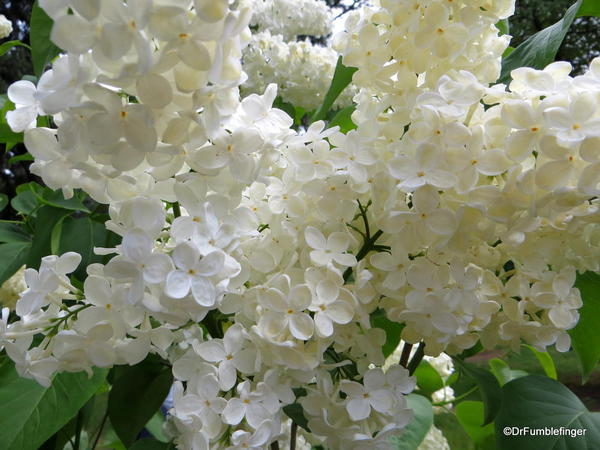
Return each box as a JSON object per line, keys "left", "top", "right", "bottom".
{"left": 29, "top": 1, "right": 60, "bottom": 78}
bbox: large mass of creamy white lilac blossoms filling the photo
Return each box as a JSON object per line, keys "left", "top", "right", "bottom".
{"left": 0, "top": 0, "right": 600, "bottom": 450}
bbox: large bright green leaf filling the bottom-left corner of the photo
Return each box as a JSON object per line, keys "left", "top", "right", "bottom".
{"left": 0, "top": 362, "right": 107, "bottom": 450}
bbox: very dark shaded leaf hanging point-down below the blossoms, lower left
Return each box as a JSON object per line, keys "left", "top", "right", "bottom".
{"left": 108, "top": 358, "right": 173, "bottom": 447}
